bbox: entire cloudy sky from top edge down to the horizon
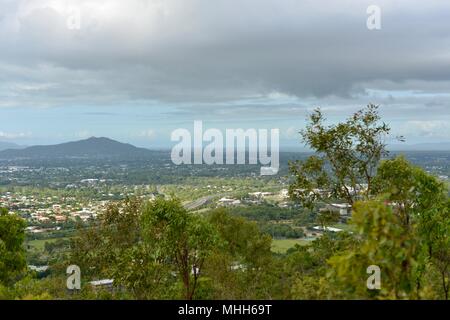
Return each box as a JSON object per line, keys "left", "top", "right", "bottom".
{"left": 0, "top": 0, "right": 450, "bottom": 147}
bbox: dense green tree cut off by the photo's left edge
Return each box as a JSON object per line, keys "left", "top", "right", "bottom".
{"left": 0, "top": 208, "right": 26, "bottom": 286}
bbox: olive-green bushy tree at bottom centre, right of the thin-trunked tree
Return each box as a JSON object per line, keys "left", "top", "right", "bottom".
{"left": 205, "top": 208, "right": 278, "bottom": 299}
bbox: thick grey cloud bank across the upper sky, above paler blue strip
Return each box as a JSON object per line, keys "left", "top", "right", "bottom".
{"left": 0, "top": 0, "right": 450, "bottom": 105}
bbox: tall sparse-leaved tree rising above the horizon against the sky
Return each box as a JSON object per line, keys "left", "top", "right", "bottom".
{"left": 289, "top": 104, "right": 390, "bottom": 208}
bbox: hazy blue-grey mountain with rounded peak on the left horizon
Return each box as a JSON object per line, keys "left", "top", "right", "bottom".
{"left": 0, "top": 137, "right": 158, "bottom": 159}
